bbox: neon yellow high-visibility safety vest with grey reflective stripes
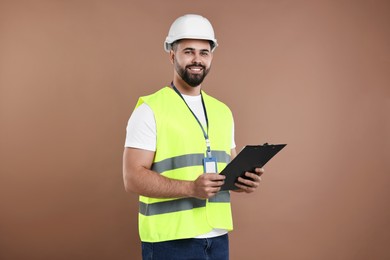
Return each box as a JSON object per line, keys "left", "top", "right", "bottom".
{"left": 136, "top": 87, "right": 233, "bottom": 242}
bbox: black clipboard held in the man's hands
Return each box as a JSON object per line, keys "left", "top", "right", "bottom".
{"left": 220, "top": 143, "right": 286, "bottom": 190}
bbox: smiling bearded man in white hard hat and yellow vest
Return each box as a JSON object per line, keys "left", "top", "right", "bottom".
{"left": 123, "top": 15, "right": 263, "bottom": 260}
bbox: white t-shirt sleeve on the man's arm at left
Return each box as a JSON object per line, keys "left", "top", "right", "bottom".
{"left": 125, "top": 103, "right": 156, "bottom": 151}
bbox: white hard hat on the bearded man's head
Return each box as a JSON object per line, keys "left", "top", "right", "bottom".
{"left": 164, "top": 14, "right": 218, "bottom": 52}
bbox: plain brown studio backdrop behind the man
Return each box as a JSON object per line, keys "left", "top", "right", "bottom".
{"left": 0, "top": 0, "right": 390, "bottom": 260}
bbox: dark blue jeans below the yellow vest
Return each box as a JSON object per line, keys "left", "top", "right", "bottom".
{"left": 142, "top": 234, "right": 229, "bottom": 260}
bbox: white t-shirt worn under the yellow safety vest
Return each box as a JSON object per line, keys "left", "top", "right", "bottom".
{"left": 125, "top": 95, "right": 236, "bottom": 238}
